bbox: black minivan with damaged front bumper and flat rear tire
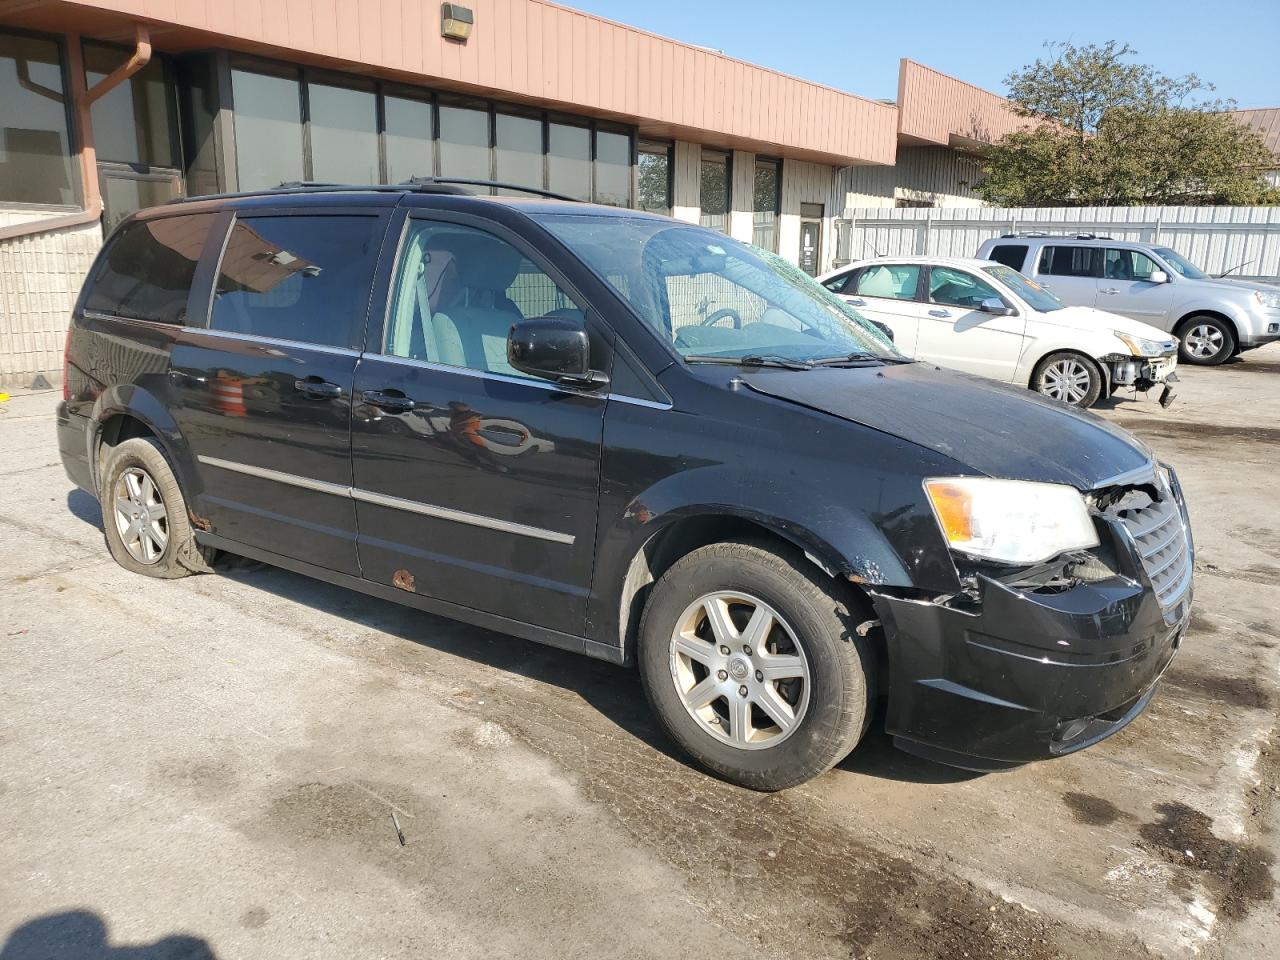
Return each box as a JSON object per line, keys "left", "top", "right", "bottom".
{"left": 58, "top": 180, "right": 1193, "bottom": 790}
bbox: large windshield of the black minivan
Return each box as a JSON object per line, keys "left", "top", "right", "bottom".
{"left": 536, "top": 215, "right": 901, "bottom": 362}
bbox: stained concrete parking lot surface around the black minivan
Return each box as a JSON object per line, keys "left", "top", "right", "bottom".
{"left": 0, "top": 344, "right": 1280, "bottom": 960}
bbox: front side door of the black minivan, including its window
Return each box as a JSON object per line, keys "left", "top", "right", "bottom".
{"left": 352, "top": 215, "right": 608, "bottom": 636}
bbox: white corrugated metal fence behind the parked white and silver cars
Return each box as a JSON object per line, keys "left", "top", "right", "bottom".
{"left": 836, "top": 206, "right": 1280, "bottom": 280}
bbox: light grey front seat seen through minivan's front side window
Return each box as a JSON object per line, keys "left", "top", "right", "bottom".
{"left": 431, "top": 236, "right": 524, "bottom": 374}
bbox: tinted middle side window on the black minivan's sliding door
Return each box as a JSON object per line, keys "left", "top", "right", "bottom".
{"left": 209, "top": 216, "right": 383, "bottom": 348}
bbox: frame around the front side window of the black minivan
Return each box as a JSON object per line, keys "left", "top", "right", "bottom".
{"left": 364, "top": 206, "right": 617, "bottom": 391}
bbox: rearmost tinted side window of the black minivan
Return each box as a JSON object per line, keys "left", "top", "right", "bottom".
{"left": 84, "top": 214, "right": 214, "bottom": 325}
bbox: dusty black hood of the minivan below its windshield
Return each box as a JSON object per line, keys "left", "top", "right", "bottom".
{"left": 739, "top": 364, "right": 1155, "bottom": 490}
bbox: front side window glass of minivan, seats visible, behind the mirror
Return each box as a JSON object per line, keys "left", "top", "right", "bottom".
{"left": 383, "top": 220, "right": 585, "bottom": 376}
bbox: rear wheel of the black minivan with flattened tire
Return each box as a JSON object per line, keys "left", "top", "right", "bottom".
{"left": 99, "top": 436, "right": 215, "bottom": 580}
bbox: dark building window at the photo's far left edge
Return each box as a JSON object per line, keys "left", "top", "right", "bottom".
{"left": 0, "top": 33, "right": 78, "bottom": 206}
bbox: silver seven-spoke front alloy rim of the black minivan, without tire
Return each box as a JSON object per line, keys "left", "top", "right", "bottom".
{"left": 671, "top": 591, "right": 810, "bottom": 750}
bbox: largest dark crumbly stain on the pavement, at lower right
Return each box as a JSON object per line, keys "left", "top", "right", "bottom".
{"left": 1138, "top": 803, "right": 1275, "bottom": 919}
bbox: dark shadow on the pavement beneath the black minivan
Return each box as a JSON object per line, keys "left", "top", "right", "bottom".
{"left": 219, "top": 561, "right": 980, "bottom": 783}
